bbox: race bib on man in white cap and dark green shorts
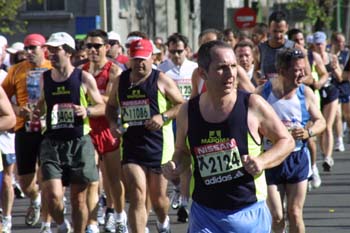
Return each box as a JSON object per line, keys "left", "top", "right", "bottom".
{"left": 51, "top": 103, "right": 74, "bottom": 129}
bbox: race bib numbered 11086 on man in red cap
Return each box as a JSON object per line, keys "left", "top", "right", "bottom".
{"left": 121, "top": 99, "right": 151, "bottom": 126}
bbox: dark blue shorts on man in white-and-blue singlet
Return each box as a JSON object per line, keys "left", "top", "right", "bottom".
{"left": 265, "top": 146, "right": 311, "bottom": 185}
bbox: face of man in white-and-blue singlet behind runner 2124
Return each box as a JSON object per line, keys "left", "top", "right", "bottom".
{"left": 283, "top": 58, "right": 305, "bottom": 86}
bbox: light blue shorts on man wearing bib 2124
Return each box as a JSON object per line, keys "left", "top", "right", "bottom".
{"left": 187, "top": 201, "right": 272, "bottom": 233}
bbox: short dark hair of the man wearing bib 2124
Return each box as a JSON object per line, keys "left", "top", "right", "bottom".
{"left": 198, "top": 40, "right": 232, "bottom": 71}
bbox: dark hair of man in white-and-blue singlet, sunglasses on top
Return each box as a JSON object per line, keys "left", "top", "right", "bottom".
{"left": 275, "top": 48, "right": 305, "bottom": 70}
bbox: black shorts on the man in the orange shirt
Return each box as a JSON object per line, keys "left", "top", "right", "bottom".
{"left": 15, "top": 128, "right": 43, "bottom": 176}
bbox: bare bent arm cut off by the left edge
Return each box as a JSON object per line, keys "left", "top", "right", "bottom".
{"left": 0, "top": 87, "right": 16, "bottom": 131}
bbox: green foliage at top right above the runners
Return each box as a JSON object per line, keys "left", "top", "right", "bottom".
{"left": 287, "top": 0, "right": 333, "bottom": 29}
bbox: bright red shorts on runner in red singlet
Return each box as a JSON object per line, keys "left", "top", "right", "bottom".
{"left": 90, "top": 116, "right": 120, "bottom": 155}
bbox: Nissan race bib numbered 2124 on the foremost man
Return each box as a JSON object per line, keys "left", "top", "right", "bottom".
{"left": 195, "top": 139, "right": 243, "bottom": 185}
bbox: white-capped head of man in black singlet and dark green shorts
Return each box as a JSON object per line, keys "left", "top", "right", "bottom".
{"left": 45, "top": 32, "right": 75, "bottom": 68}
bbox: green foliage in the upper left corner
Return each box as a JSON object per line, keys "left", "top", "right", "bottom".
{"left": 0, "top": 0, "right": 27, "bottom": 35}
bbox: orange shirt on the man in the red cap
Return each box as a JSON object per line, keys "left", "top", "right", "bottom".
{"left": 2, "top": 60, "right": 52, "bottom": 131}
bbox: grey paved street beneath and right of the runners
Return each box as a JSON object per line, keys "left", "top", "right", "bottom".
{"left": 8, "top": 144, "right": 350, "bottom": 233}
